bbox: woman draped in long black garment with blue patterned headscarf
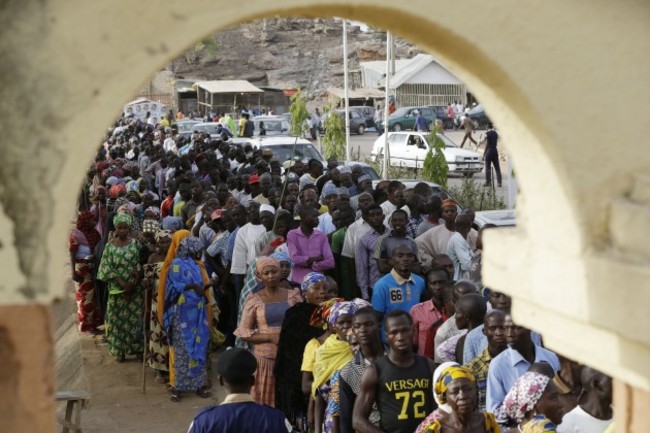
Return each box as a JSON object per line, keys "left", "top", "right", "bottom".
{"left": 271, "top": 272, "right": 327, "bottom": 430}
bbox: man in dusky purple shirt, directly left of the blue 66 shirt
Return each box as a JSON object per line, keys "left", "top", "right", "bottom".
{"left": 354, "top": 204, "right": 386, "bottom": 301}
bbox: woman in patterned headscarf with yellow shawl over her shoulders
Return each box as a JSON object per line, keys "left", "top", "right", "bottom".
{"left": 311, "top": 298, "right": 371, "bottom": 433}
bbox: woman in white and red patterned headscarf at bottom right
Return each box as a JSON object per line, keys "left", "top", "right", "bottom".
{"left": 498, "top": 371, "right": 564, "bottom": 433}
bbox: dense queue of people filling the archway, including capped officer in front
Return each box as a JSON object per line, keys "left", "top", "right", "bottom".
{"left": 69, "top": 113, "right": 612, "bottom": 433}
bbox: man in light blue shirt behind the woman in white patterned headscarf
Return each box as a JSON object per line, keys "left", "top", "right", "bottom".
{"left": 486, "top": 314, "right": 560, "bottom": 413}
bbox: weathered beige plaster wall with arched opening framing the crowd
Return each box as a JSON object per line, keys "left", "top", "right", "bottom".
{"left": 0, "top": 0, "right": 650, "bottom": 431}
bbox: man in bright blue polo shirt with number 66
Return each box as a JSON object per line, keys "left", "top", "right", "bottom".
{"left": 371, "top": 244, "right": 424, "bottom": 343}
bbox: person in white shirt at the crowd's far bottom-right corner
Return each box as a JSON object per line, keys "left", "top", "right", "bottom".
{"left": 557, "top": 367, "right": 614, "bottom": 433}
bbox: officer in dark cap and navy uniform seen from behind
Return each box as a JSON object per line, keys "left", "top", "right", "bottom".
{"left": 188, "top": 349, "right": 295, "bottom": 433}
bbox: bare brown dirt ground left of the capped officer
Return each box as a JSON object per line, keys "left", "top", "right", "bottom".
{"left": 75, "top": 334, "right": 225, "bottom": 433}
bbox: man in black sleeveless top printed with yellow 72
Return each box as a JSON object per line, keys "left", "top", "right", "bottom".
{"left": 352, "top": 310, "right": 435, "bottom": 433}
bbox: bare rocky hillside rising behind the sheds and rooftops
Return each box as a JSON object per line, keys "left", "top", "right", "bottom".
{"left": 173, "top": 18, "right": 421, "bottom": 97}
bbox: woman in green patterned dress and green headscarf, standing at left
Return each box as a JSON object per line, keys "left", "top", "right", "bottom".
{"left": 97, "top": 214, "right": 144, "bottom": 362}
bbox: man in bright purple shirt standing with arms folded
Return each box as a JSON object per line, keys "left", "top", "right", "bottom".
{"left": 287, "top": 205, "right": 334, "bottom": 284}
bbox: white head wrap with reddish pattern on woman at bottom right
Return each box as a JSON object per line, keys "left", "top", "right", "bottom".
{"left": 498, "top": 371, "right": 551, "bottom": 423}
